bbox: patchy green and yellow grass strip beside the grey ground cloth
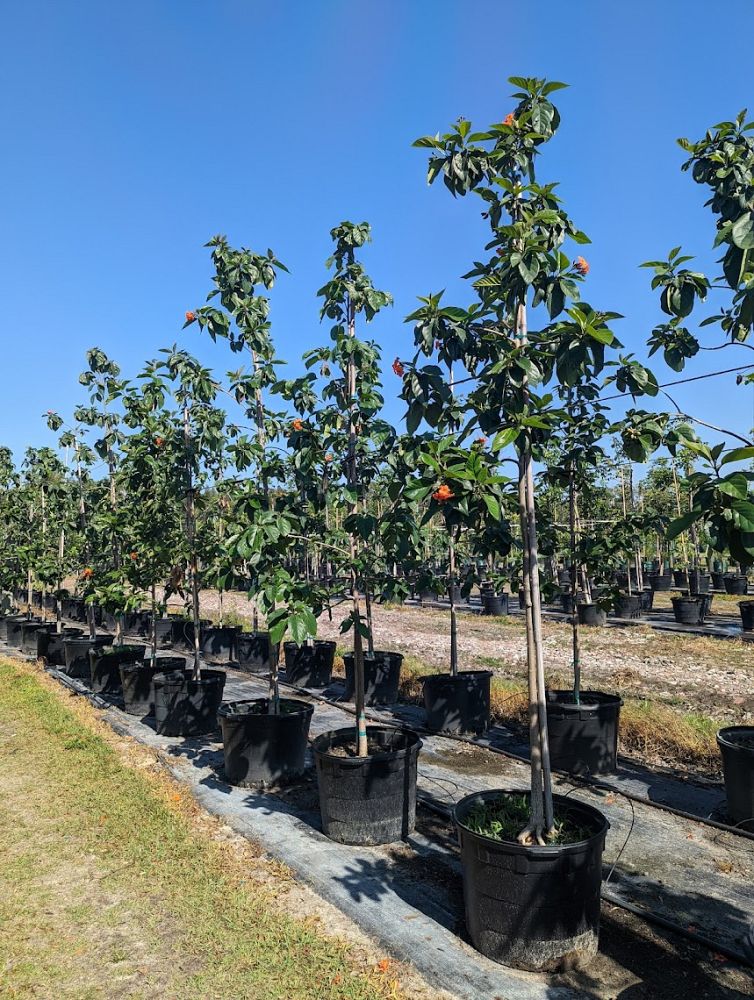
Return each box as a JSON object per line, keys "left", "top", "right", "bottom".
{"left": 0, "top": 662, "right": 406, "bottom": 1000}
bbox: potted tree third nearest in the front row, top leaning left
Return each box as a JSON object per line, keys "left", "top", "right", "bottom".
{"left": 191, "top": 236, "right": 317, "bottom": 785}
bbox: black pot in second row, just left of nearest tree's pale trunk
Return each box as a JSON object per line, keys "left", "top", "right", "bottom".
{"left": 424, "top": 670, "right": 492, "bottom": 733}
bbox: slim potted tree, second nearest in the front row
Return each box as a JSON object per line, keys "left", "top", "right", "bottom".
{"left": 309, "top": 222, "right": 421, "bottom": 844}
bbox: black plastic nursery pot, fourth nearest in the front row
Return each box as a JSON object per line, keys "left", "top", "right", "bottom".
{"left": 152, "top": 669, "right": 225, "bottom": 736}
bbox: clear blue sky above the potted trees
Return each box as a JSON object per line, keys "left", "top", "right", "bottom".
{"left": 0, "top": 0, "right": 754, "bottom": 455}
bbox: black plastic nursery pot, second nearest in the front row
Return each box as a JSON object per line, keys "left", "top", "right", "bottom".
{"left": 312, "top": 726, "right": 422, "bottom": 844}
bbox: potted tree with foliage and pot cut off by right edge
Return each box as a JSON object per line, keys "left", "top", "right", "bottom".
{"left": 638, "top": 111, "right": 754, "bottom": 826}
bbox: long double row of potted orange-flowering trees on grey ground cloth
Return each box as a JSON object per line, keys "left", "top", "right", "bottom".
{"left": 4, "top": 78, "right": 754, "bottom": 969}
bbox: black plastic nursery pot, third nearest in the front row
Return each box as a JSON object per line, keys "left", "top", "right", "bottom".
{"left": 217, "top": 698, "right": 314, "bottom": 787}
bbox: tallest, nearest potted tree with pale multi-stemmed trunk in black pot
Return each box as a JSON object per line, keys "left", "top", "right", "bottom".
{"left": 416, "top": 77, "right": 614, "bottom": 970}
